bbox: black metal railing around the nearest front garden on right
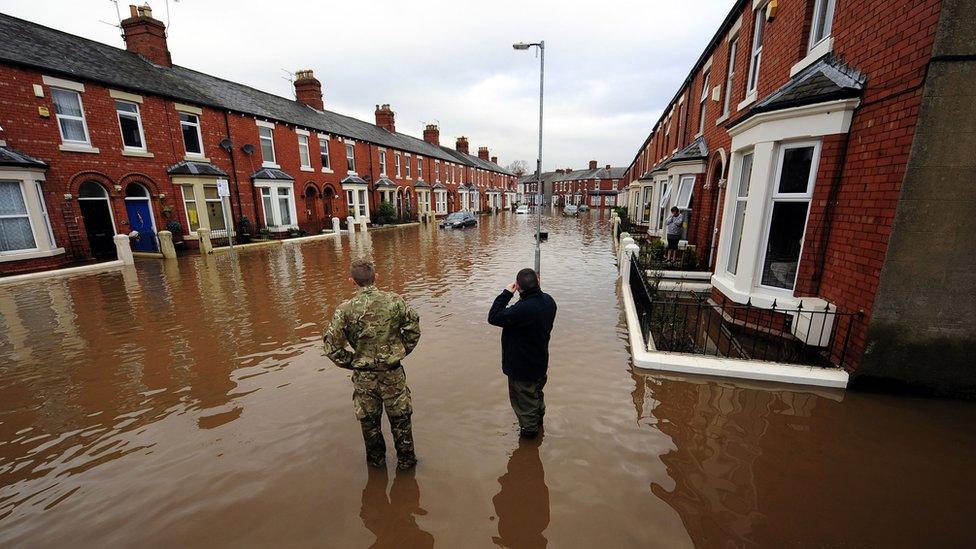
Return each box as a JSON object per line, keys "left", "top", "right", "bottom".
{"left": 630, "top": 261, "right": 861, "bottom": 367}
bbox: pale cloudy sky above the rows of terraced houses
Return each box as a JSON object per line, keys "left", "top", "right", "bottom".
{"left": 0, "top": 0, "right": 733, "bottom": 170}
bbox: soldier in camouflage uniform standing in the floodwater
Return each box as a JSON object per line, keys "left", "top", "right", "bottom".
{"left": 324, "top": 259, "right": 420, "bottom": 469}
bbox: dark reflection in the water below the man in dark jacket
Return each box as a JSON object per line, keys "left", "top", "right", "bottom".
{"left": 491, "top": 434, "right": 549, "bottom": 549}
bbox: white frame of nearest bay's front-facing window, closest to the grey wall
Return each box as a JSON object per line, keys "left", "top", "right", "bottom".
{"left": 755, "top": 140, "right": 822, "bottom": 295}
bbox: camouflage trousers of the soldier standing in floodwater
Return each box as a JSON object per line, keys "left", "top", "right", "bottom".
{"left": 352, "top": 368, "right": 417, "bottom": 468}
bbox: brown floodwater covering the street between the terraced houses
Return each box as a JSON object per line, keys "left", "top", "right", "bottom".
{"left": 0, "top": 212, "right": 976, "bottom": 547}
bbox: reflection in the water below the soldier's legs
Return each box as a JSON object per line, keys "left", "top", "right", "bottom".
{"left": 359, "top": 467, "right": 434, "bottom": 548}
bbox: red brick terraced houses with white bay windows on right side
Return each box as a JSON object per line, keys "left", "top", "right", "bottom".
{"left": 622, "top": 0, "right": 976, "bottom": 394}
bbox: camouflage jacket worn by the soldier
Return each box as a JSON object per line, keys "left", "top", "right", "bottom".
{"left": 324, "top": 286, "right": 420, "bottom": 371}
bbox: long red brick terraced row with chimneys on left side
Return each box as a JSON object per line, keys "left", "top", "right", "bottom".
{"left": 0, "top": 6, "right": 516, "bottom": 275}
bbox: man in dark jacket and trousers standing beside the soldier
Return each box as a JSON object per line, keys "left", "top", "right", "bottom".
{"left": 488, "top": 269, "right": 556, "bottom": 438}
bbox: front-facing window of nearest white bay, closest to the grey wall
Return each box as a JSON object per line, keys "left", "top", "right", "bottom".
{"left": 760, "top": 143, "right": 817, "bottom": 290}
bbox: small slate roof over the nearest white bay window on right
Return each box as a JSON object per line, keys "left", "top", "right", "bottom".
{"left": 726, "top": 55, "right": 865, "bottom": 127}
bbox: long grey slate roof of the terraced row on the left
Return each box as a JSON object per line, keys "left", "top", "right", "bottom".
{"left": 0, "top": 13, "right": 512, "bottom": 175}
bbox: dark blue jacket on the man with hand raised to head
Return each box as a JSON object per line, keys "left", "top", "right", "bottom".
{"left": 488, "top": 288, "right": 556, "bottom": 381}
